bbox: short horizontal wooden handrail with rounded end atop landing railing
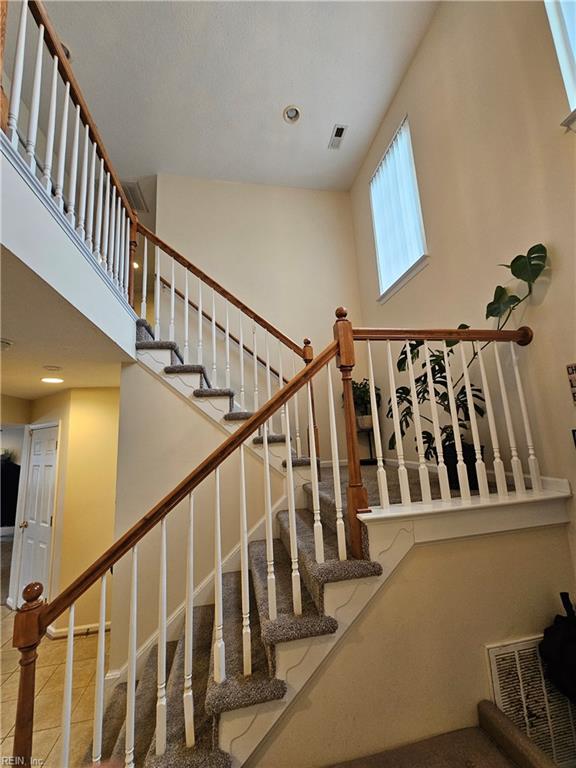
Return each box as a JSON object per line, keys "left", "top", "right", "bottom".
{"left": 352, "top": 325, "right": 534, "bottom": 347}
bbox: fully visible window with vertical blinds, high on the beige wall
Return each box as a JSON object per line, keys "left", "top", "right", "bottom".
{"left": 370, "top": 117, "right": 426, "bottom": 298}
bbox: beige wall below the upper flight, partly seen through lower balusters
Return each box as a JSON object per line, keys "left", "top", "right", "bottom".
{"left": 110, "top": 365, "right": 284, "bottom": 669}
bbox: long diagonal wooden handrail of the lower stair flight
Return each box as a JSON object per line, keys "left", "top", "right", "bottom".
{"left": 39, "top": 341, "right": 338, "bottom": 632}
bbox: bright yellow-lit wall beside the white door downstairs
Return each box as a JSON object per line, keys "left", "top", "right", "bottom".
{"left": 30, "top": 388, "right": 119, "bottom": 628}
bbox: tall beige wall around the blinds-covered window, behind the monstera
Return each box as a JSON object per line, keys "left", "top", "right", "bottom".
{"left": 352, "top": 2, "right": 576, "bottom": 560}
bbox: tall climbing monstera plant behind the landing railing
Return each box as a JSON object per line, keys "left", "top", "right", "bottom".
{"left": 386, "top": 243, "right": 548, "bottom": 490}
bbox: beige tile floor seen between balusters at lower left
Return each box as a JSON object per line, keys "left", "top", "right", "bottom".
{"left": 0, "top": 605, "right": 108, "bottom": 768}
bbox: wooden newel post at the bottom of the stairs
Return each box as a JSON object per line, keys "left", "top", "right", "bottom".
{"left": 12, "top": 581, "right": 44, "bottom": 765}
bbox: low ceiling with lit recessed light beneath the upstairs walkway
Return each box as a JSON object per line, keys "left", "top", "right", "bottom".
{"left": 0, "top": 248, "right": 129, "bottom": 400}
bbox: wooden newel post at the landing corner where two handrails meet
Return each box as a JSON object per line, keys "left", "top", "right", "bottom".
{"left": 334, "top": 307, "right": 368, "bottom": 558}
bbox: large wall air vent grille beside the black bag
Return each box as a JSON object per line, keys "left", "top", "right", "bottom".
{"left": 488, "top": 637, "right": 576, "bottom": 768}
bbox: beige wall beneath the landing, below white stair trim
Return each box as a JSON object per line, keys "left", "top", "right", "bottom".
{"left": 246, "top": 528, "right": 573, "bottom": 768}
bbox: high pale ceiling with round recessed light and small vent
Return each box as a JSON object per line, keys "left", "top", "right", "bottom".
{"left": 48, "top": 0, "right": 436, "bottom": 189}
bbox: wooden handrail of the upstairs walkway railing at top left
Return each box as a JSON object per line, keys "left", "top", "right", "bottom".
{"left": 28, "top": 0, "right": 136, "bottom": 222}
